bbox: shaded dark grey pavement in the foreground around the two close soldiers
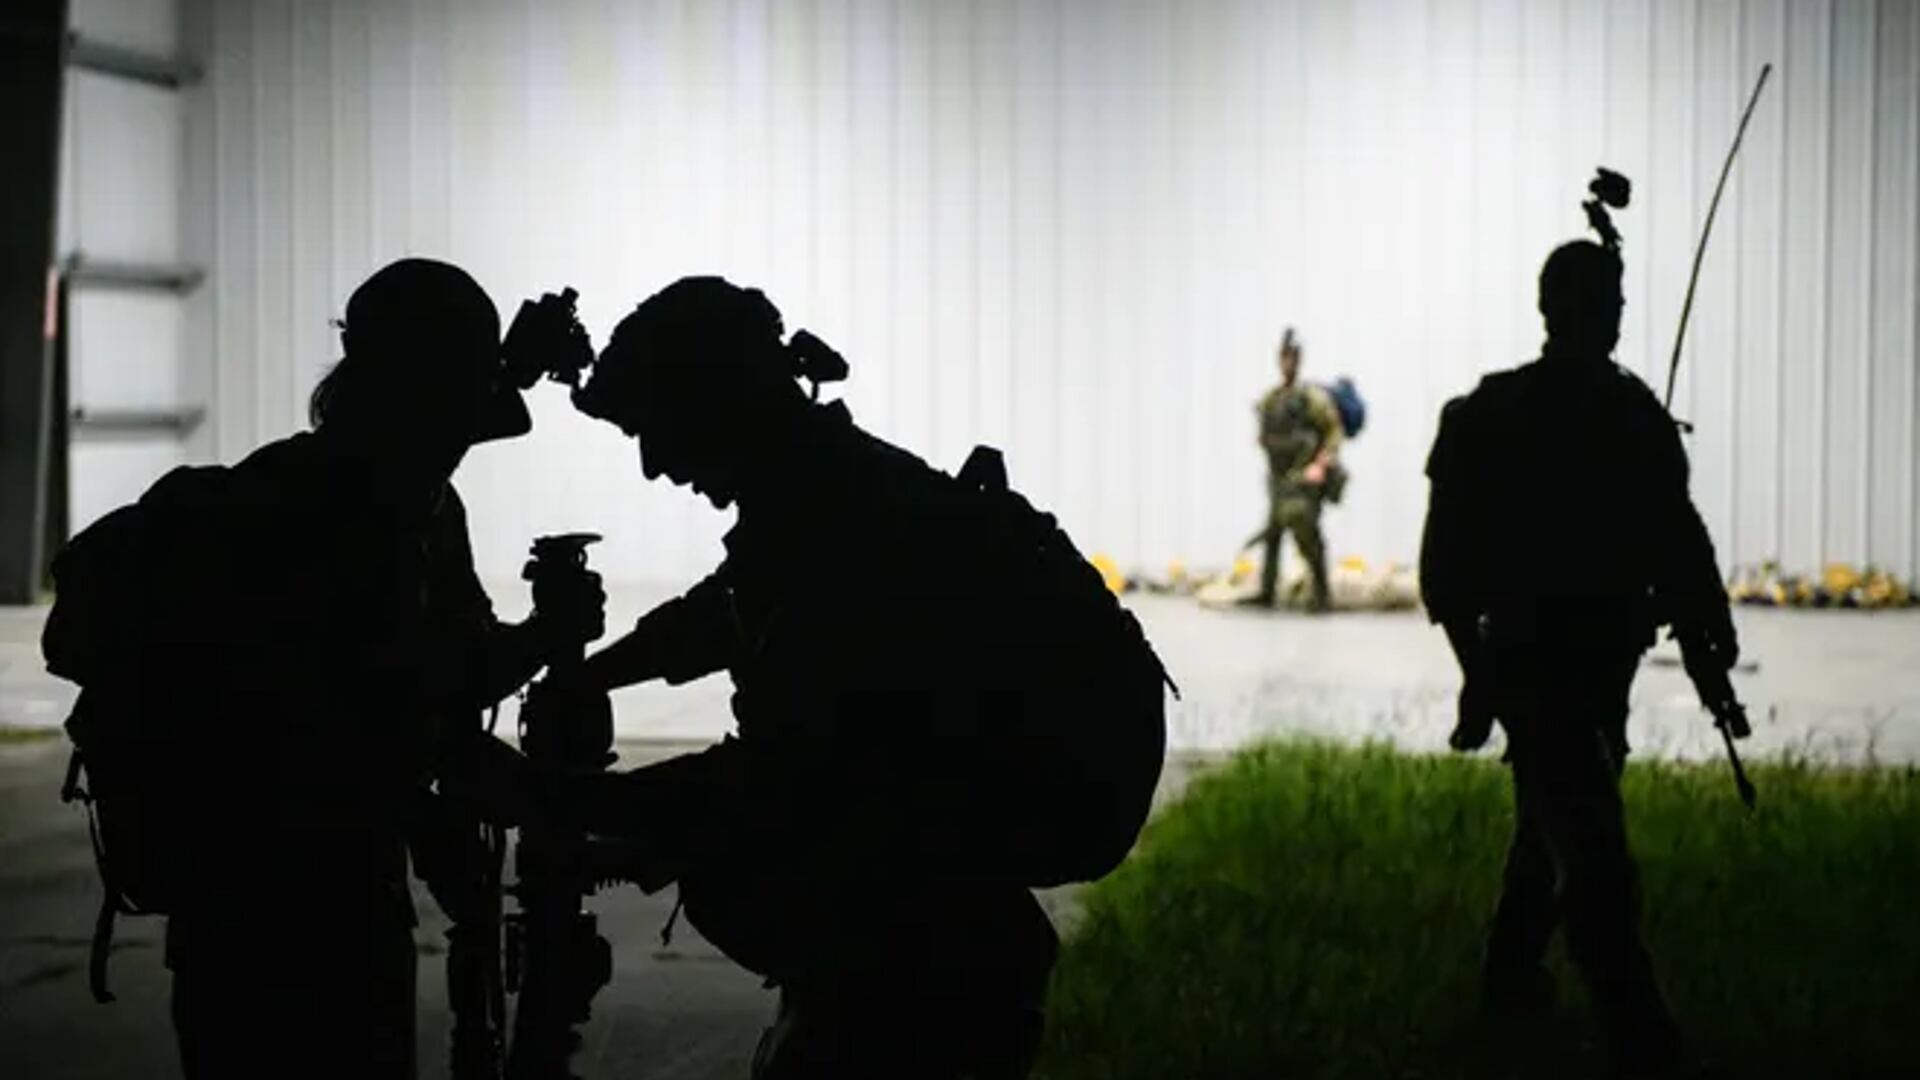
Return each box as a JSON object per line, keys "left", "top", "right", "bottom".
{"left": 0, "top": 738, "right": 1200, "bottom": 1080}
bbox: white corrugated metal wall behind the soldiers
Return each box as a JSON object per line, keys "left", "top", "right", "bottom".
{"left": 172, "top": 0, "right": 1920, "bottom": 578}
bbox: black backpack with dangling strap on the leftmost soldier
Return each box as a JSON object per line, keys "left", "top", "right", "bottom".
{"left": 40, "top": 467, "right": 225, "bottom": 1003}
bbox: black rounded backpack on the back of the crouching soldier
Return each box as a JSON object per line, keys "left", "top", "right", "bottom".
{"left": 954, "top": 446, "right": 1179, "bottom": 888}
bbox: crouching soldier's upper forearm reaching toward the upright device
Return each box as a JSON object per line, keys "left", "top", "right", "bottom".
{"left": 584, "top": 567, "right": 735, "bottom": 690}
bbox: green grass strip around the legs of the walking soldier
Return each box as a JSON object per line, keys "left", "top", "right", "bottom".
{"left": 1041, "top": 742, "right": 1920, "bottom": 1080}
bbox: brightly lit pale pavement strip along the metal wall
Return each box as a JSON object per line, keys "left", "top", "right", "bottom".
{"left": 11, "top": 582, "right": 1920, "bottom": 761}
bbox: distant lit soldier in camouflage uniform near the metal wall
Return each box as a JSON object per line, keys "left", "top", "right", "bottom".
{"left": 1248, "top": 329, "right": 1344, "bottom": 613}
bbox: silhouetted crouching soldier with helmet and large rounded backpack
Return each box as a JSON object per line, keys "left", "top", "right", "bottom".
{"left": 460, "top": 279, "right": 1165, "bottom": 1078}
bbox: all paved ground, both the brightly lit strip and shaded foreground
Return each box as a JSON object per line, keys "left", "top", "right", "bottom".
{"left": 0, "top": 590, "right": 1920, "bottom": 1080}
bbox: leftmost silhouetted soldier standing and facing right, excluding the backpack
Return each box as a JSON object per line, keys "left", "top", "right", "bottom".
{"left": 148, "top": 259, "right": 603, "bottom": 1080}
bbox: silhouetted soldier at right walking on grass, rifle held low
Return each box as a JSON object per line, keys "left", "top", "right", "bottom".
{"left": 1421, "top": 240, "right": 1738, "bottom": 1074}
